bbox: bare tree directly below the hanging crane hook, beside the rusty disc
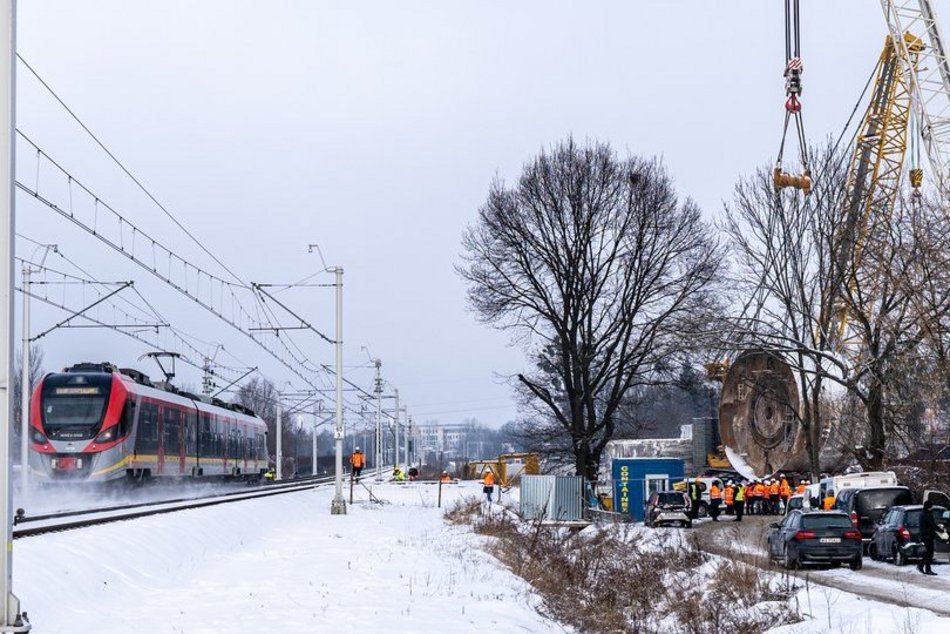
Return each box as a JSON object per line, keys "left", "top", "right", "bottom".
{"left": 724, "top": 150, "right": 847, "bottom": 474}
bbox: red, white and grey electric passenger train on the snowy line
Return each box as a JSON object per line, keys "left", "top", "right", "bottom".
{"left": 30, "top": 363, "right": 268, "bottom": 482}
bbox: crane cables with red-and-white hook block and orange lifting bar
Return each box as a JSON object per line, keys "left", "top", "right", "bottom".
{"left": 772, "top": 0, "right": 812, "bottom": 195}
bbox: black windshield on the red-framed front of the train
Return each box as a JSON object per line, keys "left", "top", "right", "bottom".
{"left": 41, "top": 374, "right": 112, "bottom": 440}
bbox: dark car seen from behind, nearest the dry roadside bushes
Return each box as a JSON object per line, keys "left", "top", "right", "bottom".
{"left": 768, "top": 510, "right": 862, "bottom": 570}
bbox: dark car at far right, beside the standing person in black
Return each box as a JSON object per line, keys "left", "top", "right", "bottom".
{"left": 868, "top": 504, "right": 950, "bottom": 566}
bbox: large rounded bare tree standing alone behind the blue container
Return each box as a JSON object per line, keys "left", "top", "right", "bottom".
{"left": 458, "top": 139, "right": 721, "bottom": 478}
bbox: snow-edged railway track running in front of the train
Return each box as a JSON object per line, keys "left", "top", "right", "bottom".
{"left": 13, "top": 476, "right": 334, "bottom": 539}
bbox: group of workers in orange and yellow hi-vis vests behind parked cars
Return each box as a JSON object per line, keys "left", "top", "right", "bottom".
{"left": 687, "top": 473, "right": 820, "bottom": 522}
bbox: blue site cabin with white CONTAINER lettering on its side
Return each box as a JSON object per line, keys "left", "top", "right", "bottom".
{"left": 611, "top": 458, "right": 684, "bottom": 522}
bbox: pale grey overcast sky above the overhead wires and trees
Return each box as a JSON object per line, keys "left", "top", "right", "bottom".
{"left": 11, "top": 0, "right": 904, "bottom": 425}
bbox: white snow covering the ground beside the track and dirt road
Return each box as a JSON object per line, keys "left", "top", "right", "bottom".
{"left": 14, "top": 482, "right": 950, "bottom": 634}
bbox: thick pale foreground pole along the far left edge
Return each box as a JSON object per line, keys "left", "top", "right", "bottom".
{"left": 0, "top": 0, "right": 30, "bottom": 632}
